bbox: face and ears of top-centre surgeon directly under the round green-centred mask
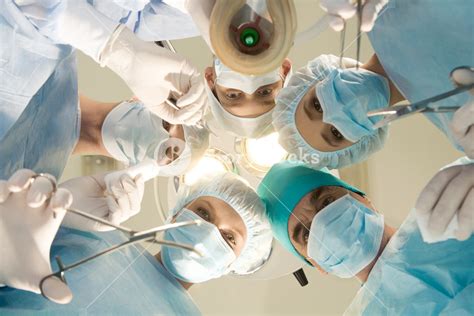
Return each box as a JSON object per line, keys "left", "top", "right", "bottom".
{"left": 205, "top": 59, "right": 291, "bottom": 117}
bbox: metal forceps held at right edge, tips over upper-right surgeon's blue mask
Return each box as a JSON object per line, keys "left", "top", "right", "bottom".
{"left": 367, "top": 83, "right": 474, "bottom": 128}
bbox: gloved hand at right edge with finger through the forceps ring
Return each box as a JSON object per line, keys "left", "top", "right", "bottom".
{"left": 451, "top": 68, "right": 474, "bottom": 159}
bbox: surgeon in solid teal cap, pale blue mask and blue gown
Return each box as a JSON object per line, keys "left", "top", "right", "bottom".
{"left": 257, "top": 162, "right": 474, "bottom": 315}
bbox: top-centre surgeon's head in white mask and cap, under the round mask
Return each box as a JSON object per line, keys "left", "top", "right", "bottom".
{"left": 204, "top": 58, "right": 291, "bottom": 138}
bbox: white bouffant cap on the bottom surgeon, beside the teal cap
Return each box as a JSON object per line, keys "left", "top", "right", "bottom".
{"left": 171, "top": 172, "right": 272, "bottom": 274}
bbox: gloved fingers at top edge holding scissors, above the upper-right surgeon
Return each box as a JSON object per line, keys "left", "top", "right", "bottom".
{"left": 319, "top": 0, "right": 388, "bottom": 32}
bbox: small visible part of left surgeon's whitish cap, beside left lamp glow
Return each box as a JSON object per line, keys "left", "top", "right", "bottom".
{"left": 182, "top": 125, "right": 209, "bottom": 170}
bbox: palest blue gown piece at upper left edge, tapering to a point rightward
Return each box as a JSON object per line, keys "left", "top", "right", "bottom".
{"left": 0, "top": 0, "right": 73, "bottom": 138}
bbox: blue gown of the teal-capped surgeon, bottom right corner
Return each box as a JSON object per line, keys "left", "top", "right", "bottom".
{"left": 346, "top": 214, "right": 474, "bottom": 316}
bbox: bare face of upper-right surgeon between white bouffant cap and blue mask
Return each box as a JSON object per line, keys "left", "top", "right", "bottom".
{"left": 295, "top": 87, "right": 353, "bottom": 152}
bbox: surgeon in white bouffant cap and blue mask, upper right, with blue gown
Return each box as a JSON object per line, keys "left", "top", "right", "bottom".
{"left": 274, "top": 0, "right": 474, "bottom": 168}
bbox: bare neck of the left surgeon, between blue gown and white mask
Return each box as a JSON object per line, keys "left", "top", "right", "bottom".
{"left": 73, "top": 96, "right": 118, "bottom": 157}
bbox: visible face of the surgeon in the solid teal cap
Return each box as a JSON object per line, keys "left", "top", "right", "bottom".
{"left": 288, "top": 186, "right": 374, "bottom": 268}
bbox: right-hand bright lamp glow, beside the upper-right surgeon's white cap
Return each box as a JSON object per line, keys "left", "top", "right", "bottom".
{"left": 245, "top": 133, "right": 288, "bottom": 170}
